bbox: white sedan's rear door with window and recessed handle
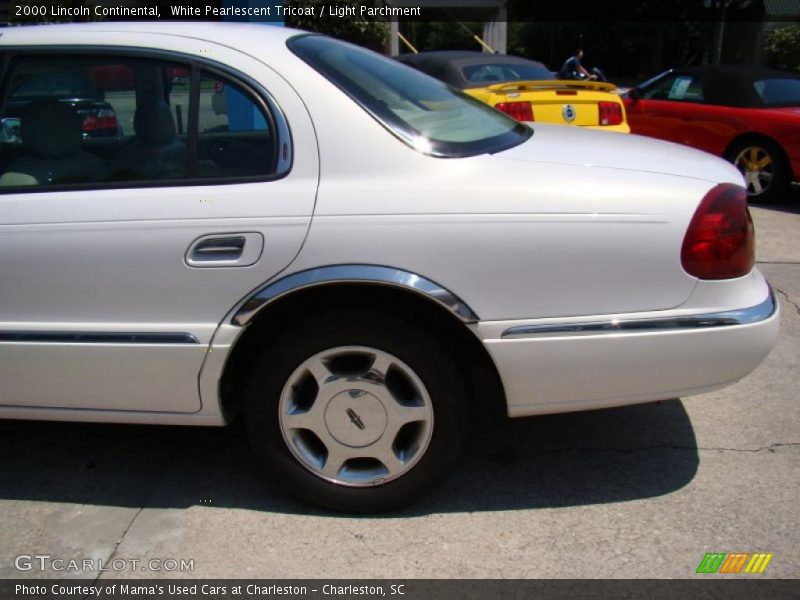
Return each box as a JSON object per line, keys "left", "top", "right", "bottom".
{"left": 0, "top": 42, "right": 319, "bottom": 413}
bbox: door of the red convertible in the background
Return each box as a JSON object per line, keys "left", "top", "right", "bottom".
{"left": 626, "top": 73, "right": 704, "bottom": 146}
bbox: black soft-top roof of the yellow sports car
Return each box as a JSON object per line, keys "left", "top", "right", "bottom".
{"left": 395, "top": 50, "right": 549, "bottom": 89}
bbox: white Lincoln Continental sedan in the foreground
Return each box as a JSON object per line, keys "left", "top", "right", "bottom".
{"left": 0, "top": 23, "right": 778, "bottom": 511}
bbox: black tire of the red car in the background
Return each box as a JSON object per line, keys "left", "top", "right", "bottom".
{"left": 725, "top": 137, "right": 791, "bottom": 204}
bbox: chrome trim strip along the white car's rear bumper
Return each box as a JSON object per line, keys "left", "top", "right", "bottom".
{"left": 500, "top": 288, "right": 777, "bottom": 339}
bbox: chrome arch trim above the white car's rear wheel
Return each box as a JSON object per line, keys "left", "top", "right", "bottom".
{"left": 231, "top": 265, "right": 479, "bottom": 325}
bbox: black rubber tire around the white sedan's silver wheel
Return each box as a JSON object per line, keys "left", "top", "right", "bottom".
{"left": 244, "top": 309, "right": 468, "bottom": 513}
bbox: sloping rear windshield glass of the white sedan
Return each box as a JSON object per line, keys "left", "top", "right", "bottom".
{"left": 288, "top": 35, "right": 532, "bottom": 157}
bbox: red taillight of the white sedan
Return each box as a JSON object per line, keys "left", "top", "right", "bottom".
{"left": 681, "top": 183, "right": 755, "bottom": 279}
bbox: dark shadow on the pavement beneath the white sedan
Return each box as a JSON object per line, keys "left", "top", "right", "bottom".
{"left": 0, "top": 400, "right": 699, "bottom": 517}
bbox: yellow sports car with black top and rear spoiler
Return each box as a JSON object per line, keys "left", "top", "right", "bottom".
{"left": 396, "top": 51, "right": 631, "bottom": 133}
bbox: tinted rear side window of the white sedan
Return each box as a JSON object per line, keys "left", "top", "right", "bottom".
{"left": 0, "top": 55, "right": 278, "bottom": 192}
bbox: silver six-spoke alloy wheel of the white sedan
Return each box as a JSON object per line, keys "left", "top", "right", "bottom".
{"left": 279, "top": 346, "right": 433, "bottom": 487}
